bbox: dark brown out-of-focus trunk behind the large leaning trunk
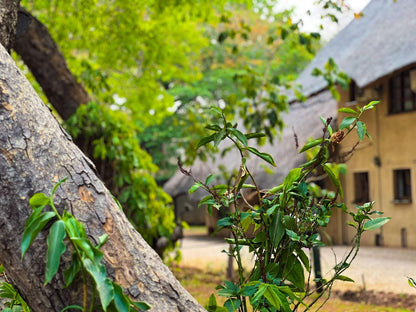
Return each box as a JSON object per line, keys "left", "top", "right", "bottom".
{"left": 13, "top": 8, "right": 90, "bottom": 120}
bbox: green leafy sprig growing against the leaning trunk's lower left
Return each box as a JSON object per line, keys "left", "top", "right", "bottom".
{"left": 21, "top": 178, "right": 151, "bottom": 312}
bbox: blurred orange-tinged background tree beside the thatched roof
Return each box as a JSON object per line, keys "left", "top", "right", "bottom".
{"left": 152, "top": 4, "right": 319, "bottom": 171}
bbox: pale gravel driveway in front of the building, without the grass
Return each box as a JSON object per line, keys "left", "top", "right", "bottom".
{"left": 182, "top": 236, "right": 416, "bottom": 294}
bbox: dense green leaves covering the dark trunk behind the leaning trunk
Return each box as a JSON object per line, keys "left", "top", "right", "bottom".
{"left": 66, "top": 103, "right": 175, "bottom": 256}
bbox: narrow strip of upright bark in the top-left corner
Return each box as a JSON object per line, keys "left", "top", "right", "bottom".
{"left": 0, "top": 0, "right": 20, "bottom": 52}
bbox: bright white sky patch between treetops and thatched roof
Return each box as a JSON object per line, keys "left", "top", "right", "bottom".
{"left": 277, "top": 0, "right": 370, "bottom": 40}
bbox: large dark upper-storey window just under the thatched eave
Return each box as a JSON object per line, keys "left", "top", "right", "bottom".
{"left": 389, "top": 70, "right": 416, "bottom": 114}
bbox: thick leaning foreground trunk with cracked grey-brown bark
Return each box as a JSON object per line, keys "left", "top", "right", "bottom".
{"left": 0, "top": 47, "right": 204, "bottom": 312}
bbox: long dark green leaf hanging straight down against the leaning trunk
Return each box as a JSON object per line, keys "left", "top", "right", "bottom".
{"left": 44, "top": 220, "right": 66, "bottom": 285}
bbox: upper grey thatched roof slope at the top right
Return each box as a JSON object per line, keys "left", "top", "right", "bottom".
{"left": 297, "top": 0, "right": 416, "bottom": 96}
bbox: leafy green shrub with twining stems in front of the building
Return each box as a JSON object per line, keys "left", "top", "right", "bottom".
{"left": 182, "top": 102, "right": 390, "bottom": 311}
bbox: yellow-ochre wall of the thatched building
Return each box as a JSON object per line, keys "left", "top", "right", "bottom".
{"left": 338, "top": 77, "right": 416, "bottom": 247}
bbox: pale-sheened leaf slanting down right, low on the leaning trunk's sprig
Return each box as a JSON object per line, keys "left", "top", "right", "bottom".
{"left": 82, "top": 257, "right": 114, "bottom": 311}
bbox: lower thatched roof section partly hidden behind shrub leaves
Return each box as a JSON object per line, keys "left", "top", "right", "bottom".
{"left": 164, "top": 91, "right": 337, "bottom": 200}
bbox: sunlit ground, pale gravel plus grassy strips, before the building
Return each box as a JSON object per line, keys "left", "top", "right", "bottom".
{"left": 177, "top": 228, "right": 416, "bottom": 312}
